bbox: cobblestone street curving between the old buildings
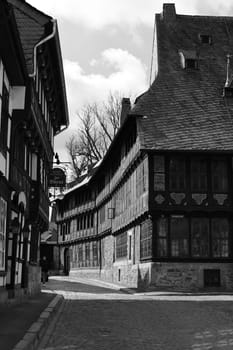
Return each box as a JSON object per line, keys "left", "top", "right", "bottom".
{"left": 39, "top": 277, "right": 233, "bottom": 350}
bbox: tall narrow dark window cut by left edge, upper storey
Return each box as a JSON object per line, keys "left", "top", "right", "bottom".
{"left": 0, "top": 83, "right": 9, "bottom": 151}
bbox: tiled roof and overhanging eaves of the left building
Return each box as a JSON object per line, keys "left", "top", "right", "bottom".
{"left": 7, "top": 0, "right": 69, "bottom": 131}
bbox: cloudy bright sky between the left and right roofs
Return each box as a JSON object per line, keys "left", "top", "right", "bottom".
{"left": 27, "top": 0, "right": 233, "bottom": 161}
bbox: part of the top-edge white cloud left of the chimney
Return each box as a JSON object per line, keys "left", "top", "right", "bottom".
{"left": 28, "top": 0, "right": 157, "bottom": 29}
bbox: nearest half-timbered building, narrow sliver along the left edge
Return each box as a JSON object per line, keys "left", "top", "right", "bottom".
{"left": 0, "top": 1, "right": 26, "bottom": 301}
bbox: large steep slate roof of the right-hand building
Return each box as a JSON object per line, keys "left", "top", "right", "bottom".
{"left": 131, "top": 4, "right": 233, "bottom": 151}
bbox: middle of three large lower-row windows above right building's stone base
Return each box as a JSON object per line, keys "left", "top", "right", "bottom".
{"left": 191, "top": 218, "right": 209, "bottom": 257}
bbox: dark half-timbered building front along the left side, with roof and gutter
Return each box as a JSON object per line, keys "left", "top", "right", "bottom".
{"left": 0, "top": 0, "right": 68, "bottom": 297}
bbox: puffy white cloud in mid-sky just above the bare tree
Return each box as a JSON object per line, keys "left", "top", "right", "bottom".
{"left": 64, "top": 48, "right": 148, "bottom": 127}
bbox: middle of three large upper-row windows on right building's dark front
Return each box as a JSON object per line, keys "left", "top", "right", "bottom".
{"left": 191, "top": 160, "right": 207, "bottom": 193}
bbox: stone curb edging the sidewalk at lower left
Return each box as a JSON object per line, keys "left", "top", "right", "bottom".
{"left": 12, "top": 295, "right": 64, "bottom": 350}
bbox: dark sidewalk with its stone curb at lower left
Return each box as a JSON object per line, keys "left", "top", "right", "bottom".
{"left": 0, "top": 292, "right": 62, "bottom": 350}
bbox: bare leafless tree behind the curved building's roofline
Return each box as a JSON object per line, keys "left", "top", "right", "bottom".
{"left": 66, "top": 92, "right": 122, "bottom": 177}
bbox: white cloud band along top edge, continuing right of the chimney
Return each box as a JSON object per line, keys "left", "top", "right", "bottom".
{"left": 28, "top": 0, "right": 232, "bottom": 29}
